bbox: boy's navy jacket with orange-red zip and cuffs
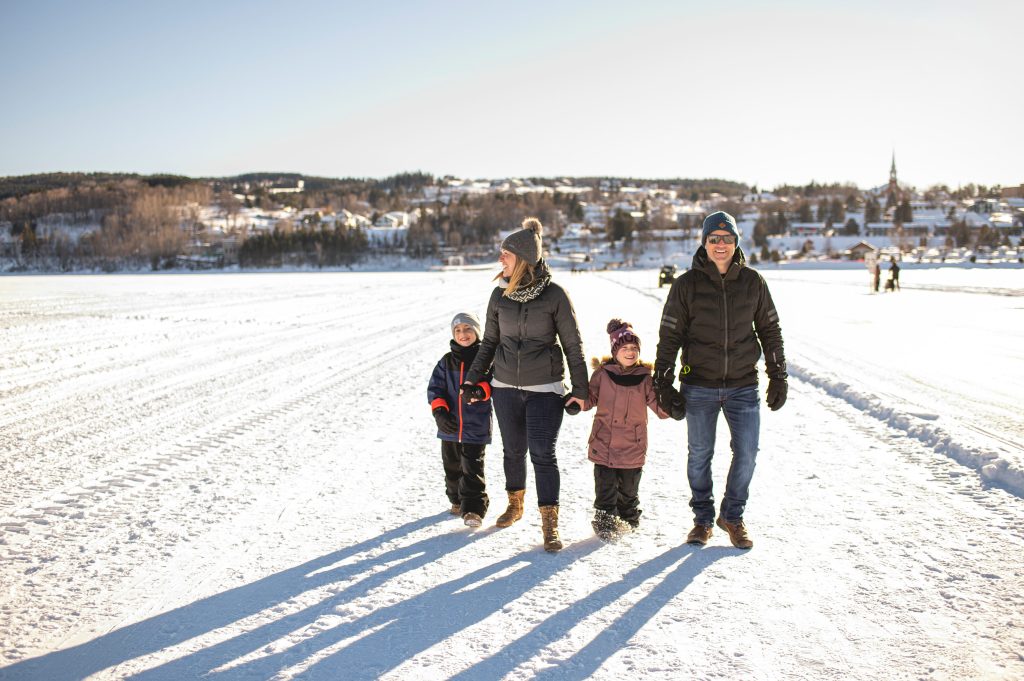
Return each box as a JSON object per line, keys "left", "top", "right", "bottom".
{"left": 427, "top": 340, "right": 492, "bottom": 444}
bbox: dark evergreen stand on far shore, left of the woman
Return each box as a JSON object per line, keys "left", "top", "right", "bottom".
{"left": 239, "top": 226, "right": 367, "bottom": 267}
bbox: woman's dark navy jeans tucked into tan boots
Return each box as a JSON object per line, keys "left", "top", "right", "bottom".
{"left": 492, "top": 388, "right": 564, "bottom": 506}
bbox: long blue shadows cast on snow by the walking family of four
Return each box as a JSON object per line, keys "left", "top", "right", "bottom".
{"left": 0, "top": 513, "right": 732, "bottom": 681}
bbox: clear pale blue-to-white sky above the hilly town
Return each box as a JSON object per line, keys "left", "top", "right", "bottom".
{"left": 0, "top": 0, "right": 1024, "bottom": 188}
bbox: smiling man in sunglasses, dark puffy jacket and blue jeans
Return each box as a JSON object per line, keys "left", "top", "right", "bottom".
{"left": 654, "top": 211, "right": 788, "bottom": 549}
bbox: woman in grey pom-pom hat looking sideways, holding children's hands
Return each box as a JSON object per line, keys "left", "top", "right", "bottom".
{"left": 463, "top": 218, "right": 588, "bottom": 551}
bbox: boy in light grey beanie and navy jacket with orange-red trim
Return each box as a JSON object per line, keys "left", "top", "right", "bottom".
{"left": 427, "top": 312, "right": 492, "bottom": 527}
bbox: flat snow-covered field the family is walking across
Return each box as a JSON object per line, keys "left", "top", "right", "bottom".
{"left": 0, "top": 268, "right": 1024, "bottom": 681}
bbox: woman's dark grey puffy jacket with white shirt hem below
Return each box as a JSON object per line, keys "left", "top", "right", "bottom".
{"left": 466, "top": 282, "right": 589, "bottom": 399}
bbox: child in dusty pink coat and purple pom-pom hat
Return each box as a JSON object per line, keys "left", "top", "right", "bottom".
{"left": 584, "top": 318, "right": 669, "bottom": 539}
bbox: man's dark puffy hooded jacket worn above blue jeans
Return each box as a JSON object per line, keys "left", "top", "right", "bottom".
{"left": 654, "top": 246, "right": 786, "bottom": 388}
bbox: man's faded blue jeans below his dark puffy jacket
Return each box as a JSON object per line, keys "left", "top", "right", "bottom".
{"left": 683, "top": 384, "right": 761, "bottom": 525}
